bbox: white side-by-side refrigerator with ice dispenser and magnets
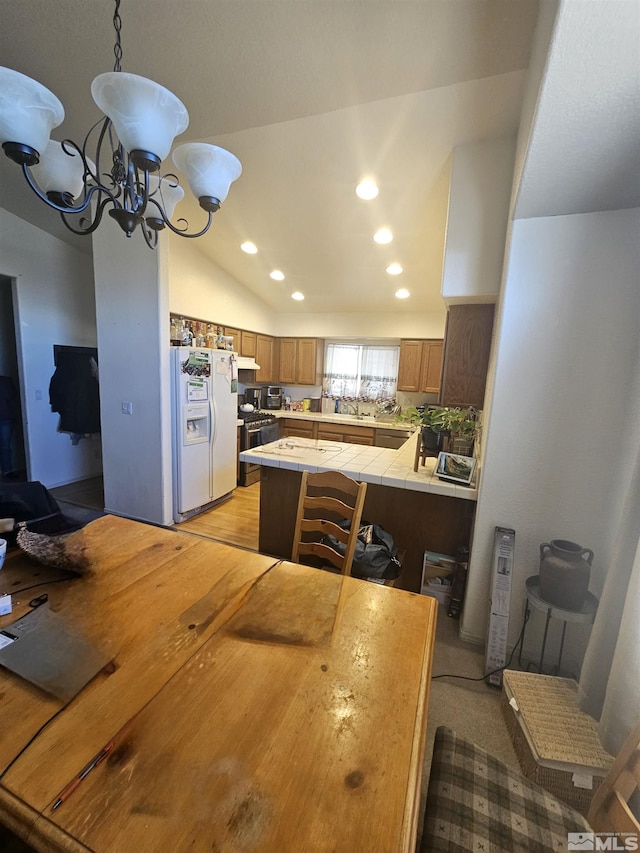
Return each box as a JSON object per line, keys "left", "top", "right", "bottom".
{"left": 171, "top": 347, "right": 238, "bottom": 523}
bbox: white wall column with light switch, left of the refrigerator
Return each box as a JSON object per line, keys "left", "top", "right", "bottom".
{"left": 93, "top": 216, "right": 172, "bottom": 524}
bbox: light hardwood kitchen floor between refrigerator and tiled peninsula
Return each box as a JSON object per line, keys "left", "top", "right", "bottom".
{"left": 174, "top": 483, "right": 260, "bottom": 551}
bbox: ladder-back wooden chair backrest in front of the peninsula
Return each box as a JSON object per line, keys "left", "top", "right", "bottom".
{"left": 291, "top": 471, "right": 367, "bottom": 575}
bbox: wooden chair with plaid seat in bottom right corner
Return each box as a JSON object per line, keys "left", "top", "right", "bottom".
{"left": 420, "top": 724, "right": 640, "bottom": 853}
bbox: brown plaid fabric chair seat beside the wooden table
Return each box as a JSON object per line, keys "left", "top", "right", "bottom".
{"left": 420, "top": 726, "right": 591, "bottom": 853}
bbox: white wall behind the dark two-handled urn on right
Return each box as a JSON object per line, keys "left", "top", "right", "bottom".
{"left": 461, "top": 209, "right": 640, "bottom": 658}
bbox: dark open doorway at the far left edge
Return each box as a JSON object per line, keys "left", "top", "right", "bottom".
{"left": 0, "top": 275, "right": 27, "bottom": 481}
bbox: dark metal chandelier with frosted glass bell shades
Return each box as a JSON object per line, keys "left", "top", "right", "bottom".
{"left": 0, "top": 0, "right": 242, "bottom": 249}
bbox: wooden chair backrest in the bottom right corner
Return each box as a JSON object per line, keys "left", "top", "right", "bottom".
{"left": 587, "top": 722, "right": 640, "bottom": 837}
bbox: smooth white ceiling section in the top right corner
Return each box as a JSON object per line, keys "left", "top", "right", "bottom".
{"left": 514, "top": 0, "right": 640, "bottom": 218}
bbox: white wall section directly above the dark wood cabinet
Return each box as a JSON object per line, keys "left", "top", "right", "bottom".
{"left": 442, "top": 137, "right": 516, "bottom": 305}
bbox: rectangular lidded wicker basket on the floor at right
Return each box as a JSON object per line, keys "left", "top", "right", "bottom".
{"left": 502, "top": 670, "right": 613, "bottom": 816}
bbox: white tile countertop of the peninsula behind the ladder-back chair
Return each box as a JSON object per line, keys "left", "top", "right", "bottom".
{"left": 240, "top": 432, "right": 478, "bottom": 501}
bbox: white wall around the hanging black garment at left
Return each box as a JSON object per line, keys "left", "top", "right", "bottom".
{"left": 0, "top": 208, "right": 102, "bottom": 488}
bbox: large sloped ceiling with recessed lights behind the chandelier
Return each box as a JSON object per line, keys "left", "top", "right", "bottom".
{"left": 0, "top": 0, "right": 538, "bottom": 313}
